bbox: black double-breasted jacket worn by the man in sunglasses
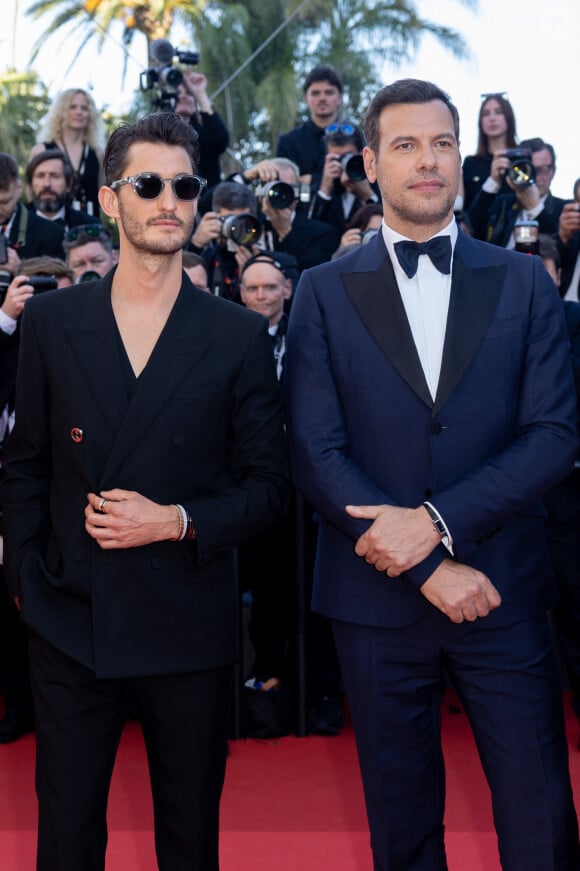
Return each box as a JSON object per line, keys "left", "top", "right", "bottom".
{"left": 3, "top": 272, "right": 289, "bottom": 677}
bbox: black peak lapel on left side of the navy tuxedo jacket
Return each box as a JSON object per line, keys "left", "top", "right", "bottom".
{"left": 341, "top": 240, "right": 433, "bottom": 407}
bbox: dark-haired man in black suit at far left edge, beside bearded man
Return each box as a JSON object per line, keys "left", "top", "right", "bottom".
{"left": 0, "top": 152, "right": 64, "bottom": 266}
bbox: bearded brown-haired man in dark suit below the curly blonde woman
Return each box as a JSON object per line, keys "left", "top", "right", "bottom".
{"left": 26, "top": 148, "right": 99, "bottom": 230}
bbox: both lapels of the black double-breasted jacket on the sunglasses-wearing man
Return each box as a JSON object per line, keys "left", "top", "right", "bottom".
{"left": 67, "top": 278, "right": 207, "bottom": 478}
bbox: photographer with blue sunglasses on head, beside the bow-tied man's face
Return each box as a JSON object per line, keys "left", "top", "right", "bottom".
{"left": 310, "top": 121, "right": 379, "bottom": 238}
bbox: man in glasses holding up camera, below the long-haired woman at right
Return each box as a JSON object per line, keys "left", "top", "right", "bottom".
{"left": 468, "top": 137, "right": 565, "bottom": 249}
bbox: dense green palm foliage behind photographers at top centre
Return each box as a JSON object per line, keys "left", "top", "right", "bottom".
{"left": 190, "top": 0, "right": 476, "bottom": 159}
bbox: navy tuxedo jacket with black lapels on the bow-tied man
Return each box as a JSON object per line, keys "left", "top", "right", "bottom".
{"left": 286, "top": 232, "right": 576, "bottom": 626}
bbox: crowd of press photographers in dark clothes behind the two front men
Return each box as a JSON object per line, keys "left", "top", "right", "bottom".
{"left": 0, "top": 59, "right": 580, "bottom": 743}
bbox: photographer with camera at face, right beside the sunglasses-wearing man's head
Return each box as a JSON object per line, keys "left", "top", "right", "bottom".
{"left": 189, "top": 181, "right": 262, "bottom": 302}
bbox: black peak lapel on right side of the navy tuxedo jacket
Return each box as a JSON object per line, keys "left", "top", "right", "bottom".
{"left": 433, "top": 233, "right": 506, "bottom": 414}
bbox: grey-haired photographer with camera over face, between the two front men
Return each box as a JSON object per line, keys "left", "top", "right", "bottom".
{"left": 234, "top": 157, "right": 339, "bottom": 272}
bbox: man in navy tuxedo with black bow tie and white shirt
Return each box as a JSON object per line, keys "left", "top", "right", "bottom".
{"left": 286, "top": 80, "right": 580, "bottom": 871}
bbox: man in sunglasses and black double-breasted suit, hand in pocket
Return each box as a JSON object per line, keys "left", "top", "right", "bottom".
{"left": 4, "top": 113, "right": 289, "bottom": 871}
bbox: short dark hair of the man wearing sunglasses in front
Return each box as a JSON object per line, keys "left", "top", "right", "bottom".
{"left": 103, "top": 112, "right": 199, "bottom": 185}
